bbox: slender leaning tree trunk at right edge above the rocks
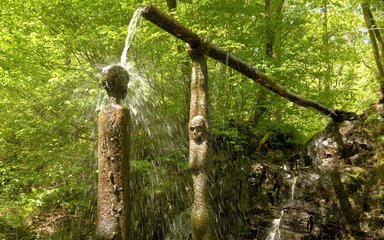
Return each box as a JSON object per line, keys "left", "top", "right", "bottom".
{"left": 361, "top": 1, "right": 384, "bottom": 100}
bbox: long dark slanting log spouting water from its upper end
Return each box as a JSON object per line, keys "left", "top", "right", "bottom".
{"left": 142, "top": 5, "right": 338, "bottom": 119}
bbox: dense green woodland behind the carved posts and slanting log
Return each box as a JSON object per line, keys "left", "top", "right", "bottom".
{"left": 0, "top": 0, "right": 384, "bottom": 239}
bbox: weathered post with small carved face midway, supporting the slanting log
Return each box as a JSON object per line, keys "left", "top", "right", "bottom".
{"left": 188, "top": 44, "right": 218, "bottom": 240}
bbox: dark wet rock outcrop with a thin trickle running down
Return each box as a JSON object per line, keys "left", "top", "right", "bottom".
{"left": 219, "top": 105, "right": 384, "bottom": 240}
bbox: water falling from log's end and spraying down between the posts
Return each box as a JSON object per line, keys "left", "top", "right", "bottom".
{"left": 101, "top": 8, "right": 191, "bottom": 240}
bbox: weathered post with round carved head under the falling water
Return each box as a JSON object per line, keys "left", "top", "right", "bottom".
{"left": 96, "top": 65, "right": 131, "bottom": 240}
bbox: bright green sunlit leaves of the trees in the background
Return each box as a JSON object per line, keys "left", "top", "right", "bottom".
{"left": 0, "top": 0, "right": 384, "bottom": 236}
